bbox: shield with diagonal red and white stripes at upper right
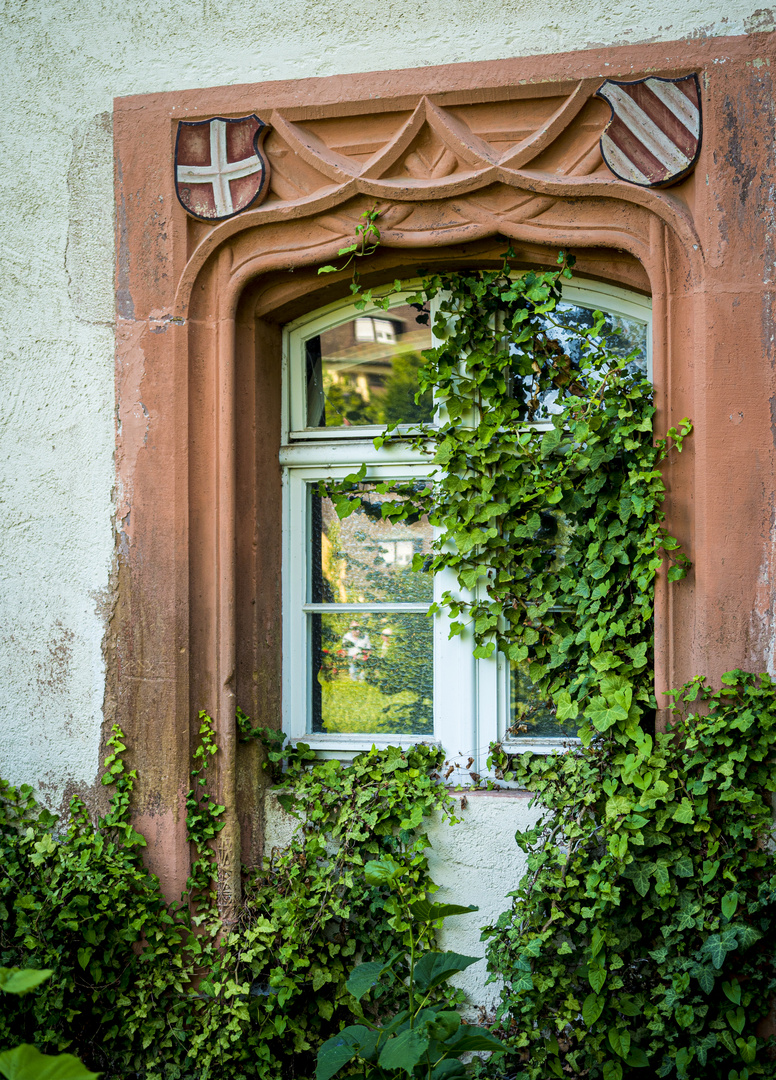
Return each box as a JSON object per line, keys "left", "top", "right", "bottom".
{"left": 596, "top": 75, "right": 702, "bottom": 188}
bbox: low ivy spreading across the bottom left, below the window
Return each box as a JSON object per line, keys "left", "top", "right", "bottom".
{"left": 0, "top": 712, "right": 457, "bottom": 1080}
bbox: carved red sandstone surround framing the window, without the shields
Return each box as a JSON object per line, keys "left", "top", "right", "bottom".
{"left": 113, "top": 35, "right": 776, "bottom": 916}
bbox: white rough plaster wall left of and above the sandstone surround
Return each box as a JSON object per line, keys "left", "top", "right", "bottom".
{"left": 0, "top": 0, "right": 776, "bottom": 802}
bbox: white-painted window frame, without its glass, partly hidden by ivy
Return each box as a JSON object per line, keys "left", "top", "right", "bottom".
{"left": 280, "top": 281, "right": 652, "bottom": 768}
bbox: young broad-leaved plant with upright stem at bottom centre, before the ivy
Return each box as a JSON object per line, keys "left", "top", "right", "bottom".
{"left": 315, "top": 855, "right": 506, "bottom": 1080}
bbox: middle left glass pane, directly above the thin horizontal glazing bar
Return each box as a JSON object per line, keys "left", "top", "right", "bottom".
{"left": 310, "top": 485, "right": 434, "bottom": 604}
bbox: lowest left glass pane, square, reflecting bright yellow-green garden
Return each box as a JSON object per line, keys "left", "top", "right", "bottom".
{"left": 308, "top": 611, "right": 434, "bottom": 735}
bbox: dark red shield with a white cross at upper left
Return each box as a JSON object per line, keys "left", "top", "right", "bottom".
{"left": 175, "top": 114, "right": 269, "bottom": 221}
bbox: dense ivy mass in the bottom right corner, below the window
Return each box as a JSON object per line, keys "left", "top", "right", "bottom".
{"left": 486, "top": 671, "right": 776, "bottom": 1080}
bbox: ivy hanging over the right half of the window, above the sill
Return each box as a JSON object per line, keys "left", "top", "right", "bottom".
{"left": 327, "top": 253, "right": 691, "bottom": 741}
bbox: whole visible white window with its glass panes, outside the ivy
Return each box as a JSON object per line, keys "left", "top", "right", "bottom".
{"left": 281, "top": 282, "right": 651, "bottom": 771}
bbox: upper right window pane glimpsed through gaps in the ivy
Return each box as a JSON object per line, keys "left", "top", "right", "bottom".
{"left": 513, "top": 302, "right": 646, "bottom": 421}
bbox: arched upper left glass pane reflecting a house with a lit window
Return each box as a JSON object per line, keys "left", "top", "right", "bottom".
{"left": 305, "top": 303, "right": 434, "bottom": 428}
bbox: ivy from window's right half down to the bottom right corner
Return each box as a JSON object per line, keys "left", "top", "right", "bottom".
{"left": 326, "top": 225, "right": 776, "bottom": 1080}
